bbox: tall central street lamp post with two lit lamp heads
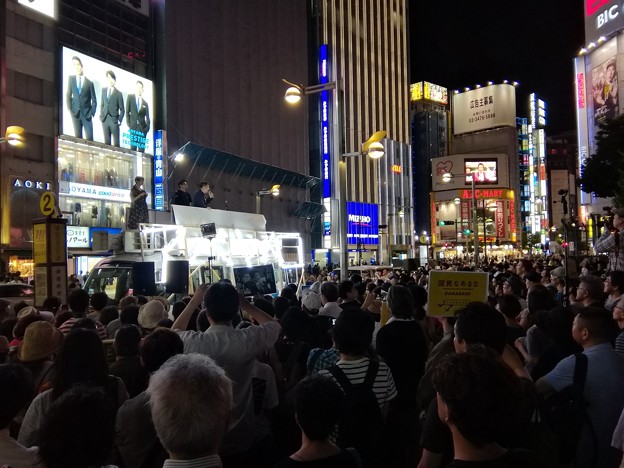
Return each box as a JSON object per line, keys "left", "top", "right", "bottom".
{"left": 282, "top": 79, "right": 386, "bottom": 280}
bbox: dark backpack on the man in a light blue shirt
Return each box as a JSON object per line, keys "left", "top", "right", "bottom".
{"left": 542, "top": 353, "right": 597, "bottom": 464}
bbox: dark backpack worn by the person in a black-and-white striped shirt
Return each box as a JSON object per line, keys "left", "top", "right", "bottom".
{"left": 329, "top": 360, "right": 384, "bottom": 467}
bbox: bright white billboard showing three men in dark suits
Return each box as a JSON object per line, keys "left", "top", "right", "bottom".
{"left": 60, "top": 47, "right": 154, "bottom": 154}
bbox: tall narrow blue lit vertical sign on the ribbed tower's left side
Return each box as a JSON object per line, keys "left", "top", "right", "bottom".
{"left": 319, "top": 44, "right": 337, "bottom": 241}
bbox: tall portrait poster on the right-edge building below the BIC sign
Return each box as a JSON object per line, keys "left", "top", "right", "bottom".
{"left": 591, "top": 56, "right": 620, "bottom": 128}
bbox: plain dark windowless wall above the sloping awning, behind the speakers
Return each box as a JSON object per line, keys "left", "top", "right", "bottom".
{"left": 165, "top": 0, "right": 308, "bottom": 174}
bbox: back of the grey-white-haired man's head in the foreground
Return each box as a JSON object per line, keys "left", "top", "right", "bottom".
{"left": 147, "top": 354, "right": 232, "bottom": 468}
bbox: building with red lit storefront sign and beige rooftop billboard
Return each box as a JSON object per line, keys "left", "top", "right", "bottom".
{"left": 428, "top": 83, "right": 521, "bottom": 262}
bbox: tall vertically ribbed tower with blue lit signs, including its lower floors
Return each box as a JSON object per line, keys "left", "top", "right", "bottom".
{"left": 309, "top": 0, "right": 413, "bottom": 264}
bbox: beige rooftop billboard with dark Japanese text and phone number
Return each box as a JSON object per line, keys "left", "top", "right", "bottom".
{"left": 453, "top": 84, "right": 516, "bottom": 135}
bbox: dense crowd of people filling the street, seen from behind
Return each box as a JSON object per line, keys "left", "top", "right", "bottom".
{"left": 0, "top": 252, "right": 624, "bottom": 468}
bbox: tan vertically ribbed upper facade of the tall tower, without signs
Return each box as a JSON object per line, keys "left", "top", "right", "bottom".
{"left": 314, "top": 0, "right": 409, "bottom": 203}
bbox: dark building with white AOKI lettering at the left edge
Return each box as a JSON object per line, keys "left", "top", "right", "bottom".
{"left": 0, "top": 0, "right": 57, "bottom": 266}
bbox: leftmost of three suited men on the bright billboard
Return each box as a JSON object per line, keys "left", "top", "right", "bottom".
{"left": 65, "top": 56, "right": 97, "bottom": 141}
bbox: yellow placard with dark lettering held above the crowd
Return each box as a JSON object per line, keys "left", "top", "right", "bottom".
{"left": 427, "top": 270, "right": 489, "bottom": 317}
